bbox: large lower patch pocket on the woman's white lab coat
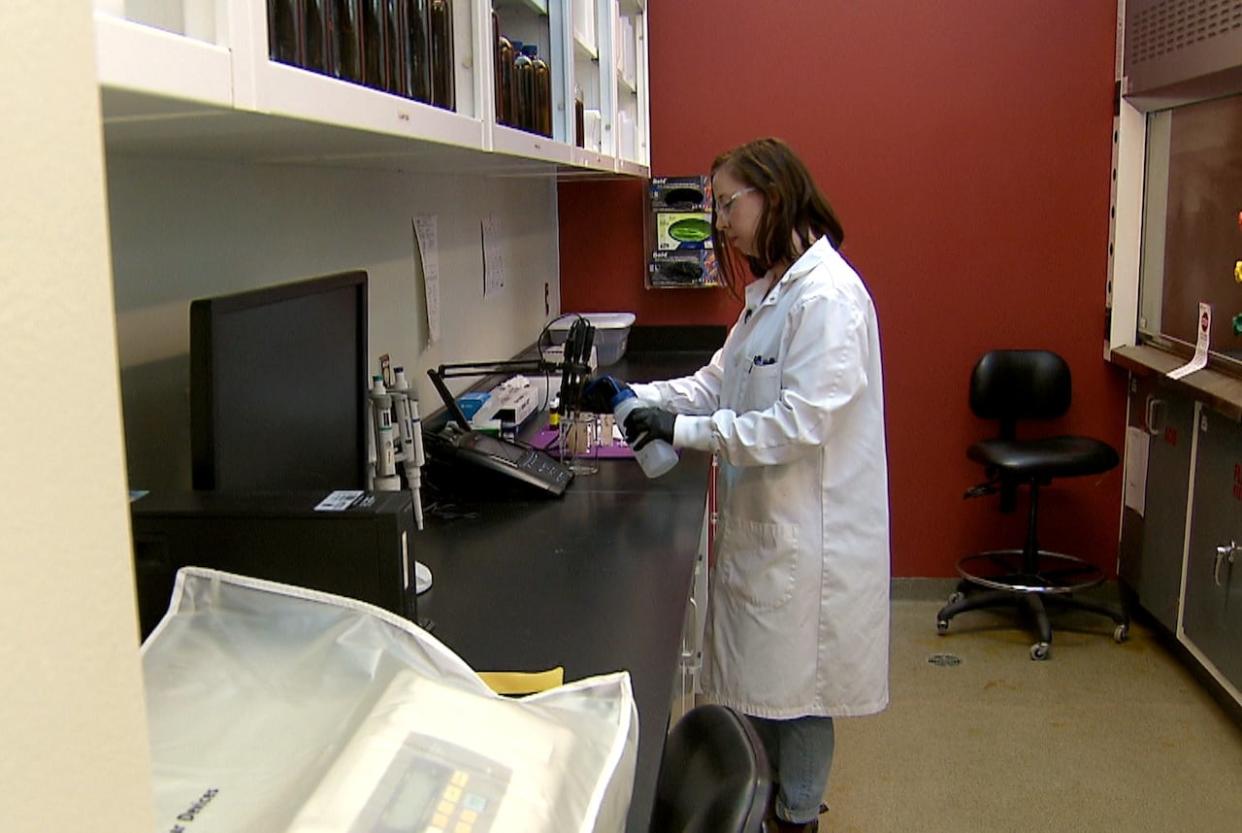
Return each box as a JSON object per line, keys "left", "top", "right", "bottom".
{"left": 717, "top": 520, "right": 799, "bottom": 610}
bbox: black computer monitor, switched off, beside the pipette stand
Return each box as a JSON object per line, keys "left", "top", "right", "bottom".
{"left": 190, "top": 272, "right": 368, "bottom": 492}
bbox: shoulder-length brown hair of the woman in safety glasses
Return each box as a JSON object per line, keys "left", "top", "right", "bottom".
{"left": 712, "top": 139, "right": 846, "bottom": 297}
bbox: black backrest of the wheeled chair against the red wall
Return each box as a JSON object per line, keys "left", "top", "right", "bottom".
{"left": 970, "top": 350, "right": 1071, "bottom": 439}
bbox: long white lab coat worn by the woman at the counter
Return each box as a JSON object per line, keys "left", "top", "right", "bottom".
{"left": 632, "top": 238, "right": 889, "bottom": 719}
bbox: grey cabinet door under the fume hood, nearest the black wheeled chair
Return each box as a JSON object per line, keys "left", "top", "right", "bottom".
{"left": 1120, "top": 377, "right": 1195, "bottom": 632}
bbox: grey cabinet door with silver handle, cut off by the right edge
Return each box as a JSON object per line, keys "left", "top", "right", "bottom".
{"left": 1182, "top": 408, "right": 1242, "bottom": 688}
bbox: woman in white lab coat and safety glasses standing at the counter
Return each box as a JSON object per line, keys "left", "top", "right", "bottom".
{"left": 596, "top": 139, "right": 889, "bottom": 831}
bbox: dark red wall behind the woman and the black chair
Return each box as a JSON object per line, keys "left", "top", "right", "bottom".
{"left": 560, "top": 0, "right": 1125, "bottom": 576}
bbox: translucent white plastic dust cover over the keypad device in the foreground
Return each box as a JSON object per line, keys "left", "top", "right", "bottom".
{"left": 143, "top": 567, "right": 638, "bottom": 833}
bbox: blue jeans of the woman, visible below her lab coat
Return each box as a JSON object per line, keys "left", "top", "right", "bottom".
{"left": 748, "top": 715, "right": 835, "bottom": 822}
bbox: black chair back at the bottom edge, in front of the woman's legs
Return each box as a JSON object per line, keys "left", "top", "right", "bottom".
{"left": 650, "top": 705, "right": 771, "bottom": 833}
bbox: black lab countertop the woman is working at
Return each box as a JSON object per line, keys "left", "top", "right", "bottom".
{"left": 415, "top": 349, "right": 710, "bottom": 833}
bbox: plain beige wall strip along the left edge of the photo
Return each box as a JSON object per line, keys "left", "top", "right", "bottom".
{"left": 0, "top": 0, "right": 154, "bottom": 833}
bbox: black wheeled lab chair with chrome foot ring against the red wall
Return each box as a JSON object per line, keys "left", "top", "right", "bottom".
{"left": 936, "top": 350, "right": 1130, "bottom": 659}
